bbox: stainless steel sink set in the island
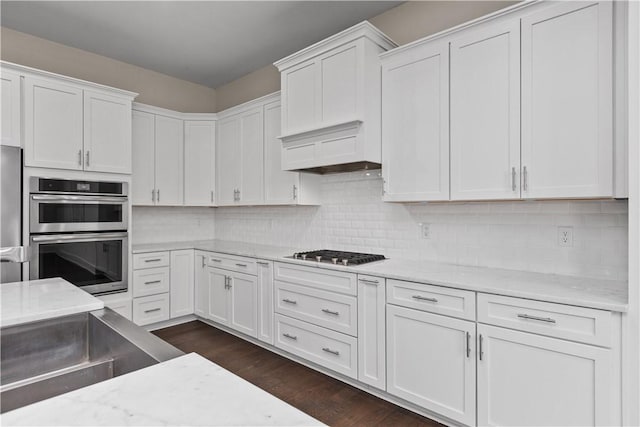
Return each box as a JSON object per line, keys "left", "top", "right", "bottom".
{"left": 0, "top": 308, "right": 184, "bottom": 412}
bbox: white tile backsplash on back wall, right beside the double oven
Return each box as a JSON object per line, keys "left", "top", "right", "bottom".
{"left": 131, "top": 206, "right": 215, "bottom": 244}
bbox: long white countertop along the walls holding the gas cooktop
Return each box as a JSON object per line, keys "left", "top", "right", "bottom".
{"left": 133, "top": 240, "right": 628, "bottom": 312}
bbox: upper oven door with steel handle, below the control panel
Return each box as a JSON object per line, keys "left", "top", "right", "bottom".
{"left": 29, "top": 194, "right": 129, "bottom": 234}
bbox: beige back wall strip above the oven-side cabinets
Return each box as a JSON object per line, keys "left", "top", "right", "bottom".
{"left": 0, "top": 27, "right": 216, "bottom": 113}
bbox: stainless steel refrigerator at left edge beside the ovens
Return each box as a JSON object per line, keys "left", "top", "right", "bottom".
{"left": 0, "top": 145, "right": 27, "bottom": 283}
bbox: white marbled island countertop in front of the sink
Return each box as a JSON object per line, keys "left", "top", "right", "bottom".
{"left": 0, "top": 353, "right": 324, "bottom": 426}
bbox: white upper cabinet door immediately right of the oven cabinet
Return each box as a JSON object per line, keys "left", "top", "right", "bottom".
{"left": 131, "top": 110, "right": 156, "bottom": 205}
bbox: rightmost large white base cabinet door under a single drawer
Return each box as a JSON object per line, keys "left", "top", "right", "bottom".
{"left": 478, "top": 325, "right": 612, "bottom": 426}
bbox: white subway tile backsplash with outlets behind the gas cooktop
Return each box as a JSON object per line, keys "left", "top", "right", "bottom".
{"left": 212, "top": 172, "right": 628, "bottom": 279}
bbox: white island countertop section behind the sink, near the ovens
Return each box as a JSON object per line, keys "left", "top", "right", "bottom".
{"left": 0, "top": 278, "right": 104, "bottom": 327}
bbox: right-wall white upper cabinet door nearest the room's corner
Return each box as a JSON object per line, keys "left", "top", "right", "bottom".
{"left": 216, "top": 116, "right": 242, "bottom": 206}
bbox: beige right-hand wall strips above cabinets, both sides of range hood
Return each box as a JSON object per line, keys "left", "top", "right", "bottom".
{"left": 216, "top": 0, "right": 518, "bottom": 111}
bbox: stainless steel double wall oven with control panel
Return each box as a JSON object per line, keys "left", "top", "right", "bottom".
{"left": 29, "top": 177, "right": 129, "bottom": 295}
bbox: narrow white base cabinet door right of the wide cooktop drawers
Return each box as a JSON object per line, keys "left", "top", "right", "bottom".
{"left": 358, "top": 275, "right": 387, "bottom": 390}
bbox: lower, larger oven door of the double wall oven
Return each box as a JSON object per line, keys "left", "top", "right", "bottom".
{"left": 29, "top": 232, "right": 129, "bottom": 295}
